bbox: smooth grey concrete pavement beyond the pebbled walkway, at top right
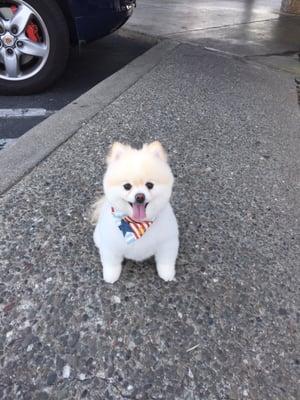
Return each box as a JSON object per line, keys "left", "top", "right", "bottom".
{"left": 125, "top": 0, "right": 300, "bottom": 56}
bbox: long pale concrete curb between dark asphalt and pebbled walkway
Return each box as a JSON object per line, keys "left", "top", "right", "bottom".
{"left": 0, "top": 36, "right": 179, "bottom": 194}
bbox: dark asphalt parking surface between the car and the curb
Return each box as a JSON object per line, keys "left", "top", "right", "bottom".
{"left": 0, "top": 34, "right": 150, "bottom": 147}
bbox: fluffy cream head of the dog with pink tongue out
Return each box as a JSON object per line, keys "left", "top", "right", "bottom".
{"left": 103, "top": 141, "right": 174, "bottom": 221}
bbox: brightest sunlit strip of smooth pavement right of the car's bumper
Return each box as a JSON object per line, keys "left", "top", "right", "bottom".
{"left": 127, "top": 0, "right": 281, "bottom": 36}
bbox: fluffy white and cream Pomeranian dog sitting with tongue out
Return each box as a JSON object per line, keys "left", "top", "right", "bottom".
{"left": 93, "top": 141, "right": 179, "bottom": 283}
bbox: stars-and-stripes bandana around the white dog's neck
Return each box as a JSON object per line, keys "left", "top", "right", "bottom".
{"left": 111, "top": 208, "right": 153, "bottom": 244}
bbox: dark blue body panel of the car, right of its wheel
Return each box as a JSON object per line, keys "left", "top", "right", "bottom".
{"left": 68, "top": 0, "right": 135, "bottom": 43}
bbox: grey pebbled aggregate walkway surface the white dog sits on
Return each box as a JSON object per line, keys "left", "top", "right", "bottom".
{"left": 0, "top": 44, "right": 300, "bottom": 400}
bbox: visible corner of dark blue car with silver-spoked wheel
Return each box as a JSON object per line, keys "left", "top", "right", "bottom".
{"left": 0, "top": 0, "right": 135, "bottom": 95}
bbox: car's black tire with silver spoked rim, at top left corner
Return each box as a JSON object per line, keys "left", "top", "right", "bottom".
{"left": 0, "top": 0, "right": 70, "bottom": 95}
